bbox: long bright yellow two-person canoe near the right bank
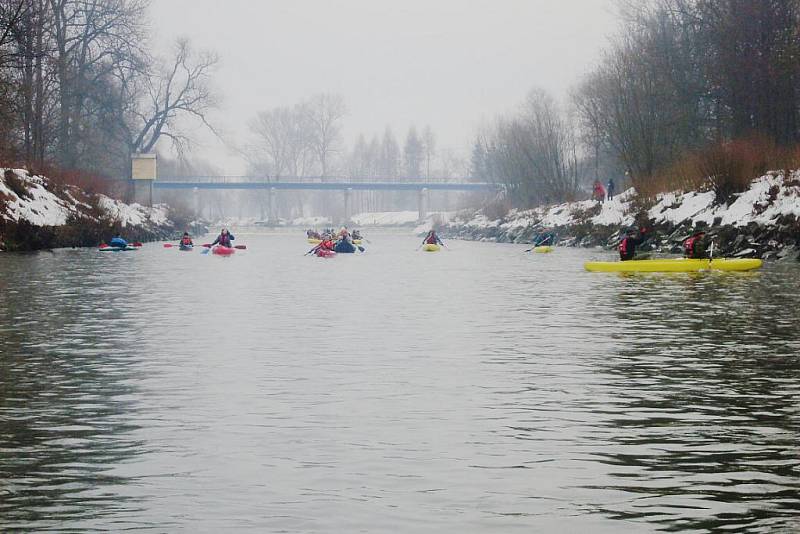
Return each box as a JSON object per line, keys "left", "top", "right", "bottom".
{"left": 583, "top": 258, "right": 763, "bottom": 273}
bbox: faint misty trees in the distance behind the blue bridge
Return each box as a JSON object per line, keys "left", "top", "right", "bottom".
{"left": 245, "top": 98, "right": 468, "bottom": 218}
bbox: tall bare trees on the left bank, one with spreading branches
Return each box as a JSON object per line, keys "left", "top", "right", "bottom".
{"left": 0, "top": 0, "right": 218, "bottom": 186}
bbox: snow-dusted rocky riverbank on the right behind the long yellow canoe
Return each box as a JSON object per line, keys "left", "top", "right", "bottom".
{"left": 442, "top": 172, "right": 800, "bottom": 260}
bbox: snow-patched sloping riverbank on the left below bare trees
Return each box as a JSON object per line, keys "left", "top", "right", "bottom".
{"left": 0, "top": 169, "right": 204, "bottom": 251}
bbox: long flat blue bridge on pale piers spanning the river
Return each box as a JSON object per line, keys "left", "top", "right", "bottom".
{"left": 151, "top": 176, "right": 501, "bottom": 220}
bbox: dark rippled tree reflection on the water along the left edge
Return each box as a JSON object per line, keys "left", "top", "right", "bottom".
{"left": 0, "top": 254, "right": 144, "bottom": 530}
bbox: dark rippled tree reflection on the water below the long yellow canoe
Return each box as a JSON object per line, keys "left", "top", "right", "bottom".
{"left": 592, "top": 269, "right": 800, "bottom": 532}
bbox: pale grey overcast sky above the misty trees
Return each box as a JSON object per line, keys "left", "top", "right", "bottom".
{"left": 152, "top": 0, "right": 616, "bottom": 174}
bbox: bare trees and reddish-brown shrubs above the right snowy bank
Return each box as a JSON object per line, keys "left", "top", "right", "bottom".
{"left": 473, "top": 0, "right": 800, "bottom": 207}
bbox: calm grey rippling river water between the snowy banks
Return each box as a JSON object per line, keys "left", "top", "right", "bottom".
{"left": 0, "top": 233, "right": 800, "bottom": 533}
